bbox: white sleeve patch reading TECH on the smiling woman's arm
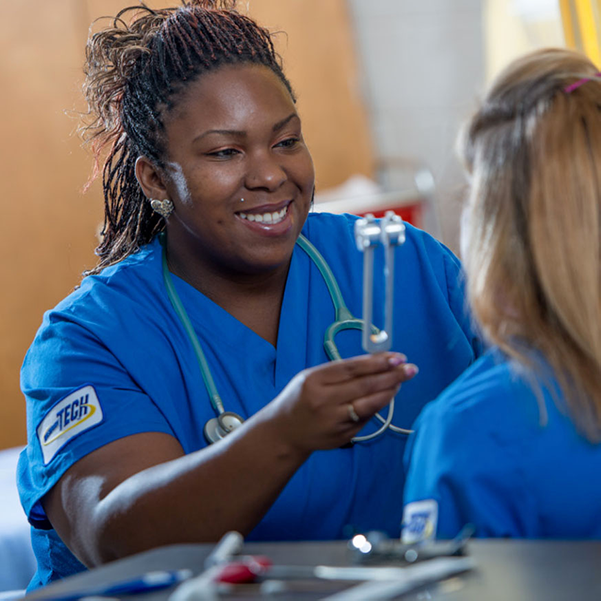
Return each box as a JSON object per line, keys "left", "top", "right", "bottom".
{"left": 36, "top": 386, "right": 103, "bottom": 465}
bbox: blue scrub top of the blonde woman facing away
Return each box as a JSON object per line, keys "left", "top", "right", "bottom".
{"left": 403, "top": 349, "right": 601, "bottom": 542}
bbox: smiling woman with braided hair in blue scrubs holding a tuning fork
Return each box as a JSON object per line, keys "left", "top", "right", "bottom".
{"left": 19, "top": 0, "right": 478, "bottom": 587}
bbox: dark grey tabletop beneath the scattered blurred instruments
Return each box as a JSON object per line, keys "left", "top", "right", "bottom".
{"left": 26, "top": 540, "right": 601, "bottom": 601}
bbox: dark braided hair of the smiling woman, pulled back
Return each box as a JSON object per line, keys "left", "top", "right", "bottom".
{"left": 82, "top": 0, "right": 294, "bottom": 275}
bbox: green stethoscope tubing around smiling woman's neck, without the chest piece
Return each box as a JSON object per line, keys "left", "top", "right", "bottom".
{"left": 159, "top": 232, "right": 411, "bottom": 442}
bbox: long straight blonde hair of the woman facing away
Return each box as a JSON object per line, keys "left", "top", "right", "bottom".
{"left": 462, "top": 49, "right": 601, "bottom": 442}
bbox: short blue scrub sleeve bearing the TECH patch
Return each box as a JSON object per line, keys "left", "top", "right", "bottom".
{"left": 18, "top": 312, "right": 173, "bottom": 528}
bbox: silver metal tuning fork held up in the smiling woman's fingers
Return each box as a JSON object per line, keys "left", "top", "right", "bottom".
{"left": 355, "top": 211, "right": 405, "bottom": 353}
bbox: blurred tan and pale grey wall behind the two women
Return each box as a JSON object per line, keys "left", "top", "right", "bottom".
{"left": 0, "top": 0, "right": 582, "bottom": 449}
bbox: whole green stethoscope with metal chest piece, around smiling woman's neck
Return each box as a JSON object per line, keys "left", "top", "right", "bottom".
{"left": 159, "top": 218, "right": 411, "bottom": 444}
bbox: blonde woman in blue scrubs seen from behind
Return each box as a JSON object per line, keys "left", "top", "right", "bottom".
{"left": 403, "top": 50, "right": 601, "bottom": 541}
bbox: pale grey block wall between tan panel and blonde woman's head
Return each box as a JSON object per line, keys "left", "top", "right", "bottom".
{"left": 348, "top": 0, "right": 485, "bottom": 251}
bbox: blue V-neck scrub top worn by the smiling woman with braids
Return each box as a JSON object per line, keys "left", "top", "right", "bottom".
{"left": 18, "top": 214, "right": 479, "bottom": 587}
